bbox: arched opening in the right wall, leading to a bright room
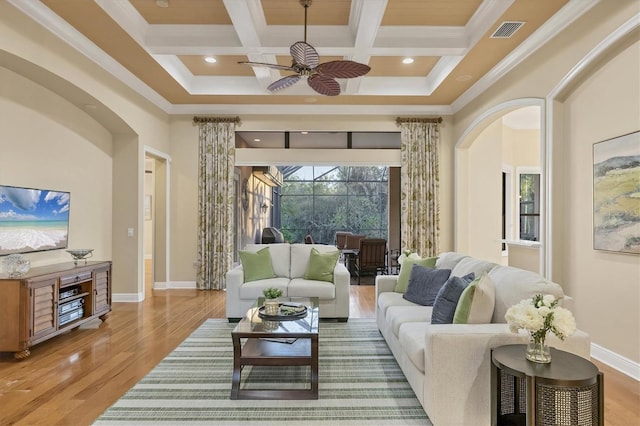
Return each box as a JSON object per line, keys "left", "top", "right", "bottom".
{"left": 455, "top": 99, "right": 544, "bottom": 272}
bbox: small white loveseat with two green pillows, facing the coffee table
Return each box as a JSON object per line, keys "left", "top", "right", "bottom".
{"left": 226, "top": 243, "right": 351, "bottom": 321}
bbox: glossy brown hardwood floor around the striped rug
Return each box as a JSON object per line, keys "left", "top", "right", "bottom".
{"left": 0, "top": 285, "right": 640, "bottom": 426}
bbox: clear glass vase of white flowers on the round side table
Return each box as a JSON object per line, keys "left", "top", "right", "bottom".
{"left": 504, "top": 294, "right": 576, "bottom": 363}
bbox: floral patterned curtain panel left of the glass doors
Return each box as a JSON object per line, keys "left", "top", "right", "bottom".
{"left": 194, "top": 119, "right": 235, "bottom": 290}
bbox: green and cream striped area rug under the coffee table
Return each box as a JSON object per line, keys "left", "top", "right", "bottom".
{"left": 95, "top": 319, "right": 431, "bottom": 426}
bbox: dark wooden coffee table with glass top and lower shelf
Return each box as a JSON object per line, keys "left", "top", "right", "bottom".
{"left": 231, "top": 297, "right": 318, "bottom": 399}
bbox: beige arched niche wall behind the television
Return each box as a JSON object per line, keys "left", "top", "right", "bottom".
{"left": 0, "top": 67, "right": 112, "bottom": 266}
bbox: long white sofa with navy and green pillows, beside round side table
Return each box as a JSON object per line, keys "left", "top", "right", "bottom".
{"left": 376, "top": 252, "right": 590, "bottom": 426}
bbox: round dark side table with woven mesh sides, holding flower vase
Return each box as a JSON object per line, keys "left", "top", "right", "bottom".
{"left": 491, "top": 345, "right": 604, "bottom": 426}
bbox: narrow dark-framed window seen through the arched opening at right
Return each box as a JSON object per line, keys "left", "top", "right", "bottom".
{"left": 519, "top": 172, "right": 540, "bottom": 241}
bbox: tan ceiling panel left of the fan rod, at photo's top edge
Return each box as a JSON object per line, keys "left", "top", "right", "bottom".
{"left": 130, "top": 0, "right": 231, "bottom": 25}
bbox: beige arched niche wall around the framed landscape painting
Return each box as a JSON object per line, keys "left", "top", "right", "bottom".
{"left": 554, "top": 38, "right": 640, "bottom": 362}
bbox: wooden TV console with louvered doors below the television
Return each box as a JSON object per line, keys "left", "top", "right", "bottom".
{"left": 0, "top": 261, "right": 111, "bottom": 359}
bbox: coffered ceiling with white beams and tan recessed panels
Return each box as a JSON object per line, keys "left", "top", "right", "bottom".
{"left": 8, "top": 0, "right": 597, "bottom": 114}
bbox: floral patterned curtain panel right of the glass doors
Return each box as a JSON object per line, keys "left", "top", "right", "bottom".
{"left": 398, "top": 119, "right": 440, "bottom": 257}
